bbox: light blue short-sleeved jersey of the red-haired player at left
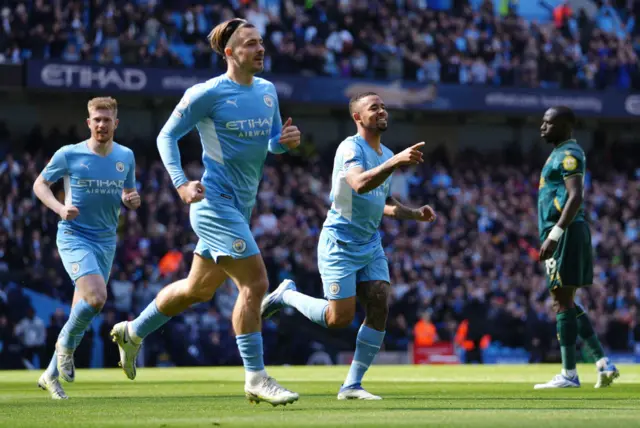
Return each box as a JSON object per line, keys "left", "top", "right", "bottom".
{"left": 42, "top": 141, "right": 136, "bottom": 239}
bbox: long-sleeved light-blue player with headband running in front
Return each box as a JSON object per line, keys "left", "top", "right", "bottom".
{"left": 111, "top": 19, "right": 300, "bottom": 406}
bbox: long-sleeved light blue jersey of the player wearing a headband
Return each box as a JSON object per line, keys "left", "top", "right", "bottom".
{"left": 157, "top": 74, "right": 286, "bottom": 212}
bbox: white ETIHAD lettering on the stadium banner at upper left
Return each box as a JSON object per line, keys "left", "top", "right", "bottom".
{"left": 40, "top": 64, "right": 147, "bottom": 91}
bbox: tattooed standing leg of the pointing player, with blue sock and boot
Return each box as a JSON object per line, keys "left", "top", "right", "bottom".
{"left": 338, "top": 281, "right": 390, "bottom": 400}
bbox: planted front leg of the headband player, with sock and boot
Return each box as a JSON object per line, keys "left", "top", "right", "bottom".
{"left": 219, "top": 254, "right": 299, "bottom": 406}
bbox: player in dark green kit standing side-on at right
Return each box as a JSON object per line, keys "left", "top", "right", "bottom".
{"left": 534, "top": 106, "right": 620, "bottom": 389}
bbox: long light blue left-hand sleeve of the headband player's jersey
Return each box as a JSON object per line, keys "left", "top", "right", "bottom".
{"left": 156, "top": 85, "right": 215, "bottom": 188}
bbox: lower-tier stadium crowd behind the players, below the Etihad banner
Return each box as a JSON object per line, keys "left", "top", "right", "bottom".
{"left": 0, "top": 124, "right": 640, "bottom": 367}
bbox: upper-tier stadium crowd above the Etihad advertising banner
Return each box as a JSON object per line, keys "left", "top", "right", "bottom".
{"left": 0, "top": 0, "right": 640, "bottom": 89}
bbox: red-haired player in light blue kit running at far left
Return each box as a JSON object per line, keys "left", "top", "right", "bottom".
{"left": 33, "top": 98, "right": 140, "bottom": 399}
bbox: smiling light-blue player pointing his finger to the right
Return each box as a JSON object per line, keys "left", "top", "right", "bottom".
{"left": 262, "top": 92, "right": 435, "bottom": 400}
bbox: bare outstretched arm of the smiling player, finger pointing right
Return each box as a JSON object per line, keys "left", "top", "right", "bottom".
{"left": 345, "top": 142, "right": 424, "bottom": 195}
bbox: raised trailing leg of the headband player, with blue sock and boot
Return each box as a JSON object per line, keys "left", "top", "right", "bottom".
{"left": 111, "top": 254, "right": 227, "bottom": 380}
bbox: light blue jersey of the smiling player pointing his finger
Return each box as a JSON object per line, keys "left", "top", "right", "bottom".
{"left": 323, "top": 135, "right": 393, "bottom": 244}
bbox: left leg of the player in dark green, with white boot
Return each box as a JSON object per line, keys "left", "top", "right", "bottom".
{"left": 534, "top": 287, "right": 580, "bottom": 389}
